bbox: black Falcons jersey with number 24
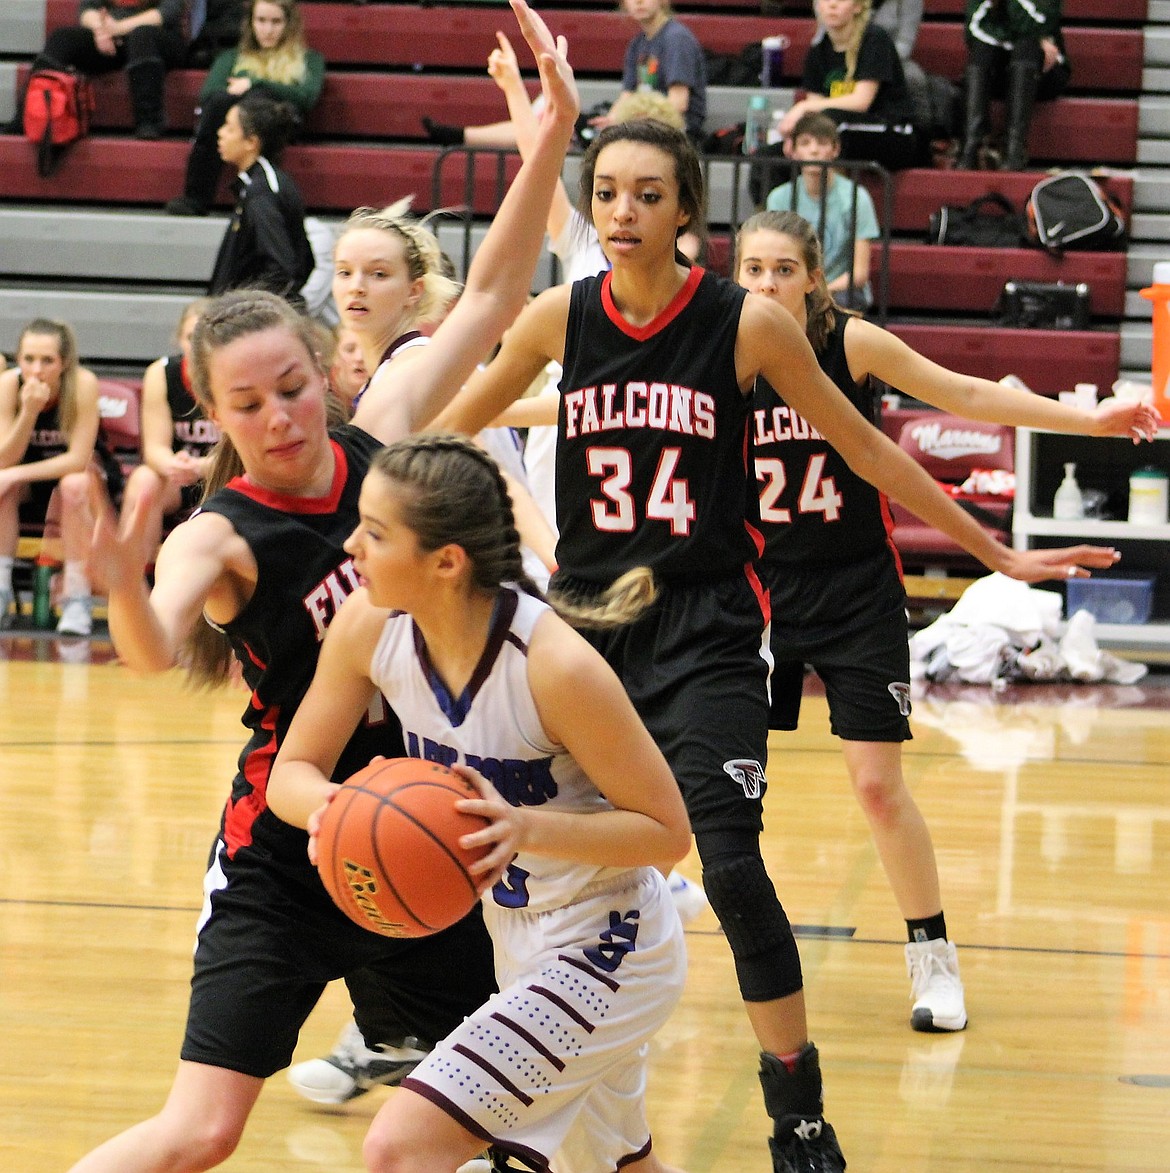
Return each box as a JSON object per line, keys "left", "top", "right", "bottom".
{"left": 752, "top": 313, "right": 893, "bottom": 565}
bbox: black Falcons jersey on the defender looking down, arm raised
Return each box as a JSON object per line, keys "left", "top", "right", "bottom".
{"left": 203, "top": 425, "right": 406, "bottom": 863}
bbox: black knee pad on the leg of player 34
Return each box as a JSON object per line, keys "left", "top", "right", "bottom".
{"left": 703, "top": 855, "right": 804, "bottom": 1002}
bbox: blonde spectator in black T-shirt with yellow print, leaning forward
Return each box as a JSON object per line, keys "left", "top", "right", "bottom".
{"left": 779, "top": 0, "right": 925, "bottom": 170}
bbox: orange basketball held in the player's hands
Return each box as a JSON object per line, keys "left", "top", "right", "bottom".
{"left": 317, "top": 758, "right": 487, "bottom": 937}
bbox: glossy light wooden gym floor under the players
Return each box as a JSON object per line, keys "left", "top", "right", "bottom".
{"left": 0, "top": 636, "right": 1170, "bottom": 1173}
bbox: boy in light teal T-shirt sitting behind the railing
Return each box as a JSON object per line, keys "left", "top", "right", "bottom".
{"left": 765, "top": 110, "right": 881, "bottom": 310}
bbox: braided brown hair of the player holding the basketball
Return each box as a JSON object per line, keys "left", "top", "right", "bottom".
{"left": 370, "top": 432, "right": 540, "bottom": 596}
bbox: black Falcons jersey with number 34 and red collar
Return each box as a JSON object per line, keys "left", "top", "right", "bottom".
{"left": 556, "top": 267, "right": 760, "bottom": 584}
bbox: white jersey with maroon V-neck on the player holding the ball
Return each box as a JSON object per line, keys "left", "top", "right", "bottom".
{"left": 370, "top": 587, "right": 630, "bottom": 911}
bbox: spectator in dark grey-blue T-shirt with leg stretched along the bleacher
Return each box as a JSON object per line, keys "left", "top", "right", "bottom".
{"left": 422, "top": 0, "right": 706, "bottom": 147}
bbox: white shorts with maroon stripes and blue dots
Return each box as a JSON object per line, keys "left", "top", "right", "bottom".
{"left": 403, "top": 868, "right": 687, "bottom": 1173}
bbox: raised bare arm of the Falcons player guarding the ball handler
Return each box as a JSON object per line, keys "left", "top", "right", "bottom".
{"left": 353, "top": 0, "right": 580, "bottom": 443}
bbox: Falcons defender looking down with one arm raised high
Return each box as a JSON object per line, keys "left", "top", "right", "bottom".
{"left": 63, "top": 0, "right": 579, "bottom": 1173}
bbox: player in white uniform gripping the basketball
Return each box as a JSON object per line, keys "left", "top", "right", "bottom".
{"left": 269, "top": 435, "right": 690, "bottom": 1173}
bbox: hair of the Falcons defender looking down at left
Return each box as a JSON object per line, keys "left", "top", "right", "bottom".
{"left": 182, "top": 290, "right": 328, "bottom": 685}
